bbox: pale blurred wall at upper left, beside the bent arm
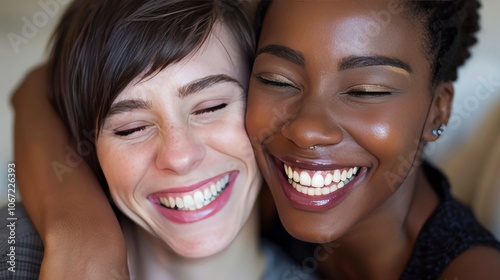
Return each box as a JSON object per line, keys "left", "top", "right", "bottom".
{"left": 0, "top": 0, "right": 70, "bottom": 205}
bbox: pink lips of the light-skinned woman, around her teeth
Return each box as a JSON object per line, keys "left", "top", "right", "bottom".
{"left": 148, "top": 171, "right": 239, "bottom": 224}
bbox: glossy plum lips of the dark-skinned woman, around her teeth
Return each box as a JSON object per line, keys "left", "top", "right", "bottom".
{"left": 274, "top": 158, "right": 368, "bottom": 212}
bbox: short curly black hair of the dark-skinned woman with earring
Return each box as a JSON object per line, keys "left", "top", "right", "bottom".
{"left": 254, "top": 0, "right": 481, "bottom": 85}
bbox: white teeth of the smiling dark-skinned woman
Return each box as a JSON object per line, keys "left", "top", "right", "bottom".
{"left": 284, "top": 164, "right": 359, "bottom": 188}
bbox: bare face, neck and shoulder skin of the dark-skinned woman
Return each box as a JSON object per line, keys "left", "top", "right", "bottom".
{"left": 247, "top": 0, "right": 500, "bottom": 279}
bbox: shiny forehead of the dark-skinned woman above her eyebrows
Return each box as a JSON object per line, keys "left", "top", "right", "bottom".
{"left": 259, "top": 0, "right": 427, "bottom": 69}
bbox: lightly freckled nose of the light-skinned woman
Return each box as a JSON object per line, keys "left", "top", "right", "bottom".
{"left": 156, "top": 127, "right": 206, "bottom": 175}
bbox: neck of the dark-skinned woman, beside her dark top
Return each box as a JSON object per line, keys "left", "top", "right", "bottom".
{"left": 325, "top": 165, "right": 439, "bottom": 279}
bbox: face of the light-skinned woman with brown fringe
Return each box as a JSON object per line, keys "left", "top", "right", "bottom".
{"left": 96, "top": 21, "right": 262, "bottom": 258}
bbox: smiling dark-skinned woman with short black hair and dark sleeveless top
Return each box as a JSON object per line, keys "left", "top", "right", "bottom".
{"left": 246, "top": 0, "right": 500, "bottom": 279}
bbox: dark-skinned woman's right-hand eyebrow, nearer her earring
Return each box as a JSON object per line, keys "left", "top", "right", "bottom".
{"left": 339, "top": 55, "right": 412, "bottom": 73}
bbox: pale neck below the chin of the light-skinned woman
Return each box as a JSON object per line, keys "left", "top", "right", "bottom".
{"left": 123, "top": 207, "right": 264, "bottom": 280}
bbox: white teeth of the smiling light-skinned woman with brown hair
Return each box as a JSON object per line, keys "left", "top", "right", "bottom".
{"left": 159, "top": 175, "right": 229, "bottom": 210}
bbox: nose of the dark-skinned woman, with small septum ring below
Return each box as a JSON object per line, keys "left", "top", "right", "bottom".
{"left": 281, "top": 99, "right": 343, "bottom": 149}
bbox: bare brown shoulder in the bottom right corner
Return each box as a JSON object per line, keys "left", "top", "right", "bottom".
{"left": 439, "top": 246, "right": 500, "bottom": 280}
